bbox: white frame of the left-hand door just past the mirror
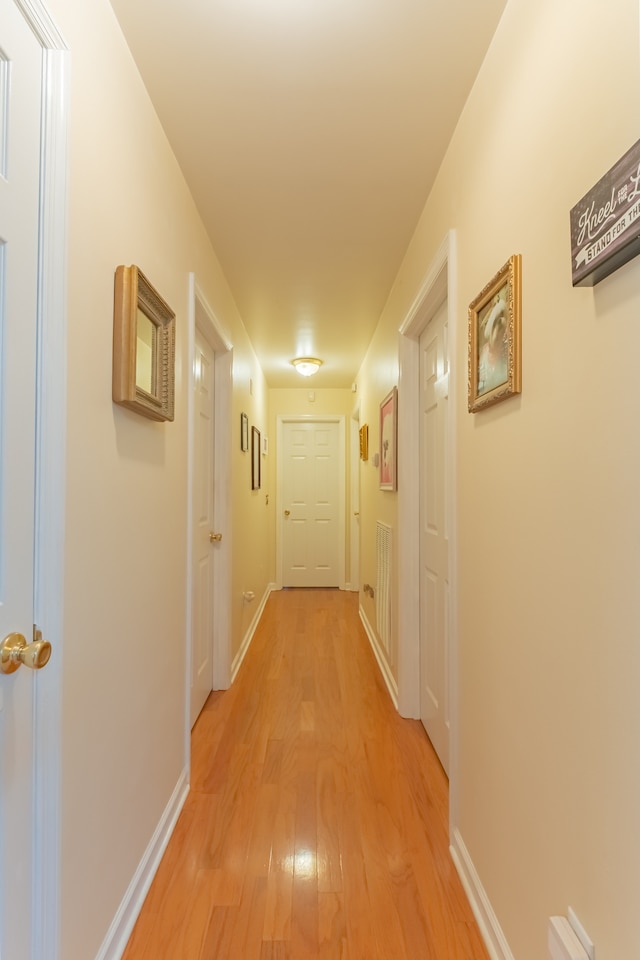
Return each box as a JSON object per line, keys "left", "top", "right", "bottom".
{"left": 185, "top": 273, "right": 233, "bottom": 752}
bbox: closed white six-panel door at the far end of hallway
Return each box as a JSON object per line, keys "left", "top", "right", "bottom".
{"left": 281, "top": 421, "right": 344, "bottom": 587}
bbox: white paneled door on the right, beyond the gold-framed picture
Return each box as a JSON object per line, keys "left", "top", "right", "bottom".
{"left": 420, "top": 302, "right": 449, "bottom": 772}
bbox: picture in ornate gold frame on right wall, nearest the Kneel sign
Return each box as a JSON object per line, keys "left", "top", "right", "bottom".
{"left": 469, "top": 254, "right": 522, "bottom": 413}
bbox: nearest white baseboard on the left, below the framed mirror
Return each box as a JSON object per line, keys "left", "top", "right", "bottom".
{"left": 96, "top": 769, "right": 189, "bottom": 960}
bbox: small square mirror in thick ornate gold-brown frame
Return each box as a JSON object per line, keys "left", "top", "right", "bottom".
{"left": 112, "top": 266, "right": 176, "bottom": 420}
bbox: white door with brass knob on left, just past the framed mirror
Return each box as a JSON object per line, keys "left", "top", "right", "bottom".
{"left": 191, "top": 330, "right": 217, "bottom": 726}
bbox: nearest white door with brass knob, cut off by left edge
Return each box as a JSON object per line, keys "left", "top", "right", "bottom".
{"left": 0, "top": 0, "right": 48, "bottom": 960}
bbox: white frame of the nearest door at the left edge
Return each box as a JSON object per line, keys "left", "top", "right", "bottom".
{"left": 23, "top": 0, "right": 69, "bottom": 960}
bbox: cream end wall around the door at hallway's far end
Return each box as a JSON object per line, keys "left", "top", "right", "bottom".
{"left": 266, "top": 381, "right": 357, "bottom": 583}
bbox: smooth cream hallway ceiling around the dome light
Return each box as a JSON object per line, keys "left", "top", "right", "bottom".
{"left": 111, "top": 0, "right": 506, "bottom": 388}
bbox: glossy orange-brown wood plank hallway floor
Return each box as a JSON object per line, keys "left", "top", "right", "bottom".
{"left": 123, "top": 590, "right": 488, "bottom": 960}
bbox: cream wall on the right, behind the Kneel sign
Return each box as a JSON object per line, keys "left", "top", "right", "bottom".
{"left": 358, "top": 0, "right": 640, "bottom": 960}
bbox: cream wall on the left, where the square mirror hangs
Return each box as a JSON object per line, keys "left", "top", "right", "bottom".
{"left": 49, "top": 0, "right": 267, "bottom": 960}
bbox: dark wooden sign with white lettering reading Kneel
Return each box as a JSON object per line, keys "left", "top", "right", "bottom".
{"left": 571, "top": 140, "right": 640, "bottom": 287}
